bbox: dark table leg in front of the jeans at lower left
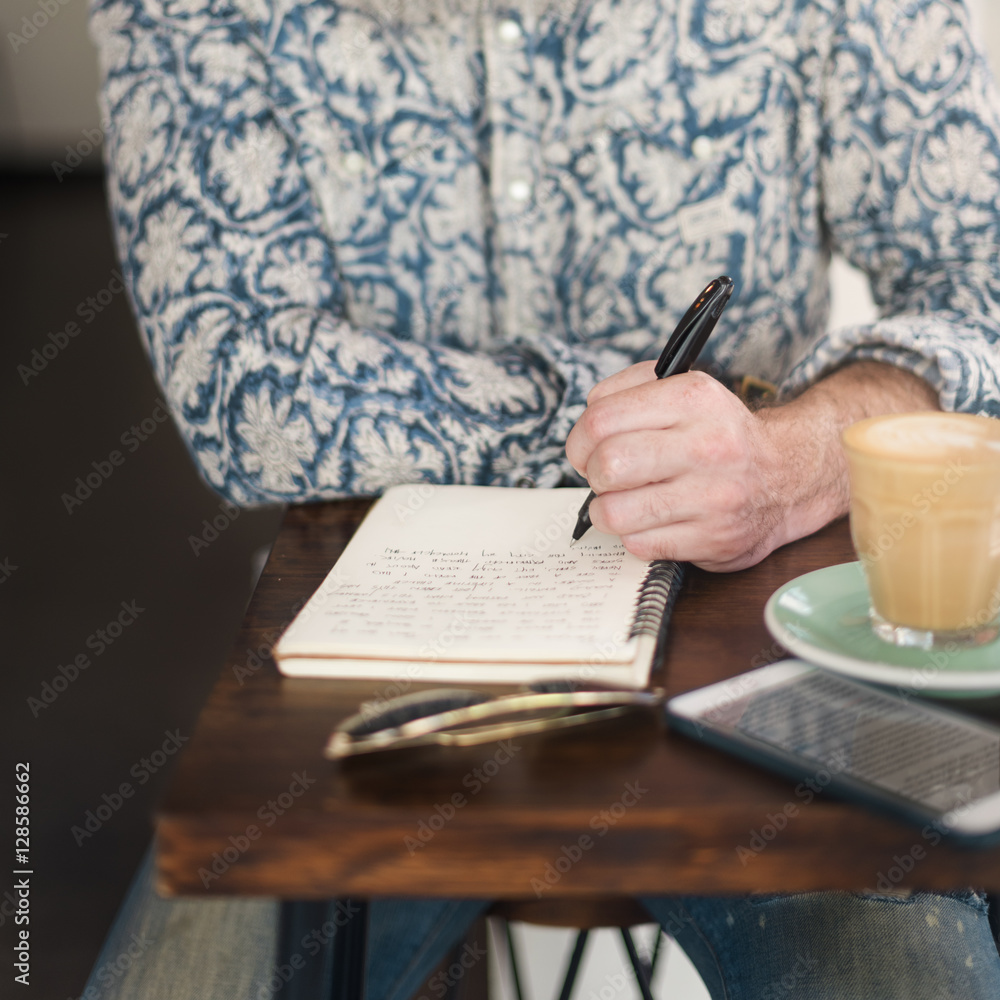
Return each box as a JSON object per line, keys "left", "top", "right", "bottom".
{"left": 273, "top": 899, "right": 368, "bottom": 1000}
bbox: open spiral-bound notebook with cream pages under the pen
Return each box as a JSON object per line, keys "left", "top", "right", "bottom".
{"left": 274, "top": 484, "right": 681, "bottom": 687}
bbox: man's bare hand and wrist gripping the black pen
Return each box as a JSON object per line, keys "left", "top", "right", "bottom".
{"left": 566, "top": 361, "right": 937, "bottom": 571}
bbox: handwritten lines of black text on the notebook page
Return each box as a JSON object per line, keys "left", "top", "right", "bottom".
{"left": 324, "top": 545, "right": 625, "bottom": 658}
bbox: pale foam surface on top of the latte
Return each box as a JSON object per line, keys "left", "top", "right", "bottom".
{"left": 844, "top": 413, "right": 1000, "bottom": 461}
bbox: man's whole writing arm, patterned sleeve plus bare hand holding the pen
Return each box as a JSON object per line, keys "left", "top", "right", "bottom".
{"left": 567, "top": 0, "right": 1000, "bottom": 570}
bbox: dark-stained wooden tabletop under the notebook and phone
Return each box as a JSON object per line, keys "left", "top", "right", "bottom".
{"left": 156, "top": 500, "right": 1000, "bottom": 900}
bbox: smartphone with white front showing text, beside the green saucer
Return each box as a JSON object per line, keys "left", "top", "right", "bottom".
{"left": 666, "top": 660, "right": 1000, "bottom": 846}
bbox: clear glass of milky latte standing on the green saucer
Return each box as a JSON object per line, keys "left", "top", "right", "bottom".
{"left": 843, "top": 413, "right": 1000, "bottom": 649}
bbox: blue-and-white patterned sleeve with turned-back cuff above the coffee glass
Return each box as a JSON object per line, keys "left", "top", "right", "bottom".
{"left": 782, "top": 0, "right": 1000, "bottom": 417}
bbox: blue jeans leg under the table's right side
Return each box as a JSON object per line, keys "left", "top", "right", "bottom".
{"left": 642, "top": 891, "right": 1000, "bottom": 1000}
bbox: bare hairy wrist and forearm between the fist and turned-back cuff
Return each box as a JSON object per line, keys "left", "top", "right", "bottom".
{"left": 756, "top": 361, "right": 939, "bottom": 548}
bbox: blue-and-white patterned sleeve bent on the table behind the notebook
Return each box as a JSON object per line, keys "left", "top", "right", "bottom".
{"left": 91, "top": 0, "right": 630, "bottom": 504}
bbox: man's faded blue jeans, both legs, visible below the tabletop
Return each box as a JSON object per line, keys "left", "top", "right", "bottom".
{"left": 82, "top": 856, "right": 1000, "bottom": 1000}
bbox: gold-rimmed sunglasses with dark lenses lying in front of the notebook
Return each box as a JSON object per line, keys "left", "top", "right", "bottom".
{"left": 324, "top": 681, "right": 664, "bottom": 760}
